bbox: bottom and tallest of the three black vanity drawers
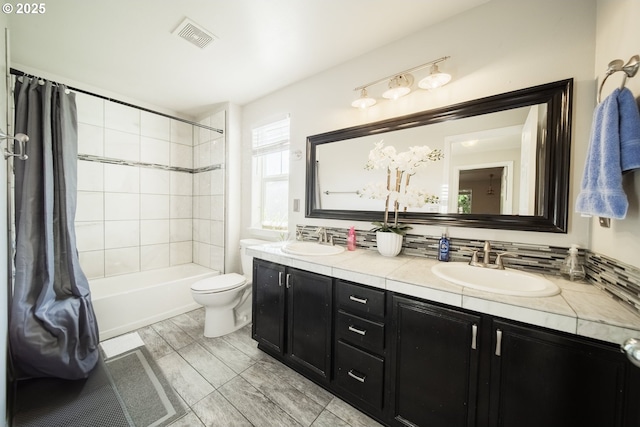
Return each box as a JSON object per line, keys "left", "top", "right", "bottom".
{"left": 335, "top": 341, "right": 384, "bottom": 408}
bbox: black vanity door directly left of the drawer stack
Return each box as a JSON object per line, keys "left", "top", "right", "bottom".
{"left": 285, "top": 268, "right": 333, "bottom": 381}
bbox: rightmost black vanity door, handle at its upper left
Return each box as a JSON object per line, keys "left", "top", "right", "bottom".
{"left": 489, "top": 320, "right": 637, "bottom": 427}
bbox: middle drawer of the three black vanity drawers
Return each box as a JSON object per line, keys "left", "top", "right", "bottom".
{"left": 336, "top": 310, "right": 384, "bottom": 353}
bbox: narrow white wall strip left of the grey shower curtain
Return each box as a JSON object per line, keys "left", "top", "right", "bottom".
{"left": 0, "top": 20, "right": 9, "bottom": 426}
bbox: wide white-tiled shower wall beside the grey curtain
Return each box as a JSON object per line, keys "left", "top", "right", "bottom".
{"left": 76, "top": 94, "right": 194, "bottom": 278}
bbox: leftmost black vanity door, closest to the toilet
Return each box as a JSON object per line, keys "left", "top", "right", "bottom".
{"left": 252, "top": 259, "right": 285, "bottom": 354}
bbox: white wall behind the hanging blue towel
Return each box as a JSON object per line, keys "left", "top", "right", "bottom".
{"left": 590, "top": 0, "right": 640, "bottom": 267}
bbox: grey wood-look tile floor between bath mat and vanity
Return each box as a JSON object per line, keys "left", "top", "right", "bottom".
{"left": 137, "top": 309, "right": 380, "bottom": 427}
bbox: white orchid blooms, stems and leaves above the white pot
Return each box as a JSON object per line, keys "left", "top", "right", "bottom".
{"left": 359, "top": 141, "right": 444, "bottom": 236}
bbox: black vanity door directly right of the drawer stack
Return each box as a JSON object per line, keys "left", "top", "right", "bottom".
{"left": 390, "top": 296, "right": 481, "bottom": 427}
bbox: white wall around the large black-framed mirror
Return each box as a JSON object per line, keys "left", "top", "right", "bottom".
{"left": 242, "top": 0, "right": 596, "bottom": 251}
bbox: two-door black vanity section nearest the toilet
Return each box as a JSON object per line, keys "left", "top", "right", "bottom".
{"left": 252, "top": 260, "right": 333, "bottom": 383}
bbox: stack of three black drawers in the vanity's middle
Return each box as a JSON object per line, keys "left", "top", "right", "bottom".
{"left": 333, "top": 280, "right": 386, "bottom": 414}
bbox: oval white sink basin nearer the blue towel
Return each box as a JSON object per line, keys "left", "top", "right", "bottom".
{"left": 431, "top": 262, "right": 560, "bottom": 297}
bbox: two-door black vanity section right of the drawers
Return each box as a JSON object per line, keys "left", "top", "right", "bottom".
{"left": 388, "top": 295, "right": 640, "bottom": 427}
